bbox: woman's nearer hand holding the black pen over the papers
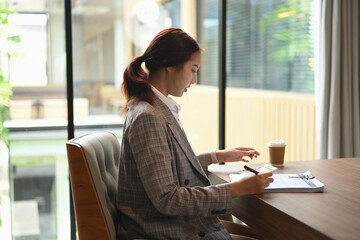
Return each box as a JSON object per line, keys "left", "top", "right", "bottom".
{"left": 230, "top": 172, "right": 274, "bottom": 198}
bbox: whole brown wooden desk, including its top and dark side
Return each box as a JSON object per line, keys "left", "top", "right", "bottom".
{"left": 209, "top": 158, "right": 360, "bottom": 239}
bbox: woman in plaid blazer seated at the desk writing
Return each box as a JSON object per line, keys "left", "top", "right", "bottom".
{"left": 117, "top": 28, "right": 272, "bottom": 239}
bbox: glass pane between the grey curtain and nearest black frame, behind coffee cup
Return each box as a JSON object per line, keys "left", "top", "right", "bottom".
{"left": 226, "top": 0, "right": 316, "bottom": 162}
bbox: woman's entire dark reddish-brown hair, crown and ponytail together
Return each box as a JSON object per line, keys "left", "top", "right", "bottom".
{"left": 121, "top": 28, "right": 200, "bottom": 113}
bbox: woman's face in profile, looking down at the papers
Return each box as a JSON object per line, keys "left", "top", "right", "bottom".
{"left": 168, "top": 51, "right": 201, "bottom": 97}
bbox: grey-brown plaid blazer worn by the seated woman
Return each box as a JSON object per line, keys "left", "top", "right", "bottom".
{"left": 117, "top": 96, "right": 232, "bottom": 239}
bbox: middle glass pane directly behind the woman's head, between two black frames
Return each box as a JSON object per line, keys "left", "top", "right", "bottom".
{"left": 72, "top": 0, "right": 217, "bottom": 151}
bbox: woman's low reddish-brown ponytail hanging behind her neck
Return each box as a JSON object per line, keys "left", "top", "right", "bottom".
{"left": 121, "top": 56, "right": 154, "bottom": 114}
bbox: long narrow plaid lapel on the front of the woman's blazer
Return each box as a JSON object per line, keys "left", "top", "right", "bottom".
{"left": 155, "top": 96, "right": 208, "bottom": 179}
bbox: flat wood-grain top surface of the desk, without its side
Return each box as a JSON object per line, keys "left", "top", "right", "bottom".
{"left": 210, "top": 158, "right": 360, "bottom": 239}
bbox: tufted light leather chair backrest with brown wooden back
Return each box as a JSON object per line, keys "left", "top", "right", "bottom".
{"left": 66, "top": 132, "right": 120, "bottom": 240}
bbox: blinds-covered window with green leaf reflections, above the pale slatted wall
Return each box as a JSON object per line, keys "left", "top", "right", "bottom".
{"left": 227, "top": 0, "right": 314, "bottom": 93}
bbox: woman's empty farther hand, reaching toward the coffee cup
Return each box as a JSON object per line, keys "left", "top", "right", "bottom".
{"left": 216, "top": 147, "right": 260, "bottom": 162}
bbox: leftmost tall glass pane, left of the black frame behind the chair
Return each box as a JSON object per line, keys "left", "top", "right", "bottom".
{"left": 0, "top": 0, "right": 70, "bottom": 239}
